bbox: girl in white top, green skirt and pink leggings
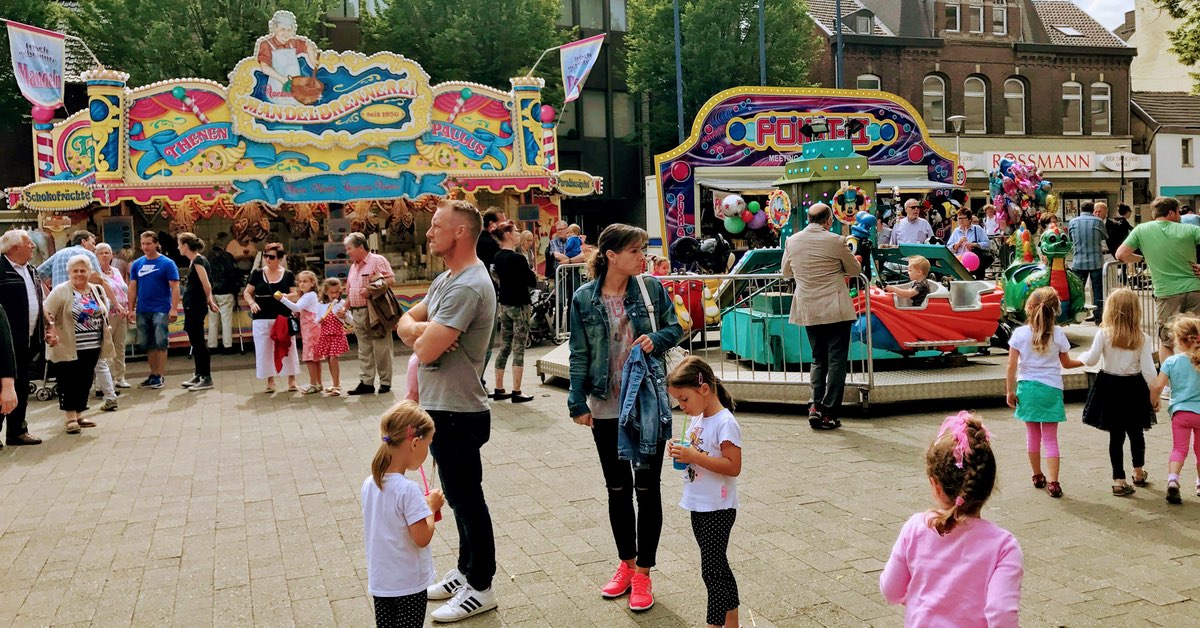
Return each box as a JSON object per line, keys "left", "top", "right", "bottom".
{"left": 1006, "top": 286, "right": 1084, "bottom": 497}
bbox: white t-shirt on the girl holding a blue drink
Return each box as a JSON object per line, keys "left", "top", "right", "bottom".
{"left": 679, "top": 409, "right": 742, "bottom": 513}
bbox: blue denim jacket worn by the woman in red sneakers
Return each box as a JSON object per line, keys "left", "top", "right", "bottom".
{"left": 566, "top": 277, "right": 683, "bottom": 417}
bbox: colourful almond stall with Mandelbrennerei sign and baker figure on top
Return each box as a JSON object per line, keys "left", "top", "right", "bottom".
{"left": 7, "top": 24, "right": 601, "bottom": 343}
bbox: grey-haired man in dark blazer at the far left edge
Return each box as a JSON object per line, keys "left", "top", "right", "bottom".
{"left": 0, "top": 229, "right": 46, "bottom": 445}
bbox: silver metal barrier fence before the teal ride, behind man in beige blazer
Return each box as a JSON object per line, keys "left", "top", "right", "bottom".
{"left": 556, "top": 267, "right": 875, "bottom": 407}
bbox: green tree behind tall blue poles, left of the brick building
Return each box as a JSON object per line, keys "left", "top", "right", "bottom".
{"left": 625, "top": 0, "right": 817, "bottom": 152}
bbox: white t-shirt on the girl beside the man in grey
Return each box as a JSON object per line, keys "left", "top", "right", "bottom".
{"left": 362, "top": 473, "right": 436, "bottom": 598}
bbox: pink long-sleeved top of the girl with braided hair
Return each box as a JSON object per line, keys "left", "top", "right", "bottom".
{"left": 880, "top": 513, "right": 1025, "bottom": 628}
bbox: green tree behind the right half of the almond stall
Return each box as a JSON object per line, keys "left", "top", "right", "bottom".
{"left": 362, "top": 0, "right": 575, "bottom": 99}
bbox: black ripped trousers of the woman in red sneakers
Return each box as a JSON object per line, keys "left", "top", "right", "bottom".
{"left": 592, "top": 419, "right": 666, "bottom": 569}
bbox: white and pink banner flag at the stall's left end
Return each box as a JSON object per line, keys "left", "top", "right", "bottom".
{"left": 5, "top": 19, "right": 66, "bottom": 108}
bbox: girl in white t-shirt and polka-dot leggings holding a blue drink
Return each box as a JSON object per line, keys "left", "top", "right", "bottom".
{"left": 667, "top": 355, "right": 742, "bottom": 628}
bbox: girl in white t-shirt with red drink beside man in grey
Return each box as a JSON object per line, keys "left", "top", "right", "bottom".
{"left": 362, "top": 400, "right": 445, "bottom": 628}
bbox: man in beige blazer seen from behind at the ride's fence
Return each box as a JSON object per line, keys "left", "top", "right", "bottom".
{"left": 781, "top": 203, "right": 863, "bottom": 430}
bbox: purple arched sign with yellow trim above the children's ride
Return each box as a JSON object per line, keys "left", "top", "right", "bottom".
{"left": 654, "top": 88, "right": 956, "bottom": 253}
